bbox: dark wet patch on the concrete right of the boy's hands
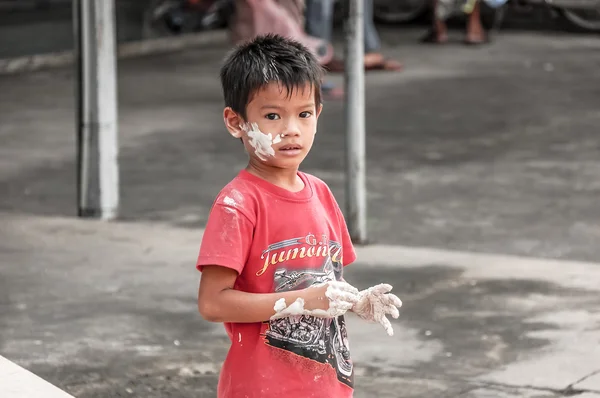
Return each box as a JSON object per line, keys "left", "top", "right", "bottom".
{"left": 345, "top": 264, "right": 600, "bottom": 379}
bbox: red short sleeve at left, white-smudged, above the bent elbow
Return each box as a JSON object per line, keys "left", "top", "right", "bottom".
{"left": 196, "top": 203, "right": 254, "bottom": 274}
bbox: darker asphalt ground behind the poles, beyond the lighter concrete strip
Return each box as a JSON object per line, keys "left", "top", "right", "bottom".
{"left": 0, "top": 30, "right": 600, "bottom": 261}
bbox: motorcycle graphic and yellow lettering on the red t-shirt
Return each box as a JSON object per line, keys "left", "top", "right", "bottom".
{"left": 259, "top": 235, "right": 354, "bottom": 387}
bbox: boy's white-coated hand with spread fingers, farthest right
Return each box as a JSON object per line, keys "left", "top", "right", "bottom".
{"left": 352, "top": 283, "right": 402, "bottom": 336}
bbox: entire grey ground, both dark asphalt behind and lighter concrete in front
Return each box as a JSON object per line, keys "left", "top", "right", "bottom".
{"left": 0, "top": 29, "right": 600, "bottom": 398}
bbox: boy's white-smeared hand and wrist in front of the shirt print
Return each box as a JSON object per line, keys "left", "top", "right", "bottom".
{"left": 271, "top": 281, "right": 358, "bottom": 319}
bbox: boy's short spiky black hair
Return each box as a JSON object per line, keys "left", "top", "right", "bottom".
{"left": 221, "top": 34, "right": 323, "bottom": 119}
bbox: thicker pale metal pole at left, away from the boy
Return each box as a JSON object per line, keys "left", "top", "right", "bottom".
{"left": 73, "top": 0, "right": 119, "bottom": 220}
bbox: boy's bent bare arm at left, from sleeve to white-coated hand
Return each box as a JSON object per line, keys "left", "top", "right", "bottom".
{"left": 198, "top": 265, "right": 358, "bottom": 323}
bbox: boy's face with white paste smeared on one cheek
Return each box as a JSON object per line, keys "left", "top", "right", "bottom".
{"left": 224, "top": 83, "right": 322, "bottom": 169}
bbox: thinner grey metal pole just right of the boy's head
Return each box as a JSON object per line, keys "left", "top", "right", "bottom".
{"left": 344, "top": 0, "right": 367, "bottom": 244}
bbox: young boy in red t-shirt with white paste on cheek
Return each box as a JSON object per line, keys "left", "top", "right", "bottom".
{"left": 197, "top": 35, "right": 402, "bottom": 398}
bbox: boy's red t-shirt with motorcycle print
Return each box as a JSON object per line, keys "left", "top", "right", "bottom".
{"left": 197, "top": 170, "right": 356, "bottom": 398}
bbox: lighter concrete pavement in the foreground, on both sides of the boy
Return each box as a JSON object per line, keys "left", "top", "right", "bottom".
{"left": 0, "top": 213, "right": 600, "bottom": 398}
